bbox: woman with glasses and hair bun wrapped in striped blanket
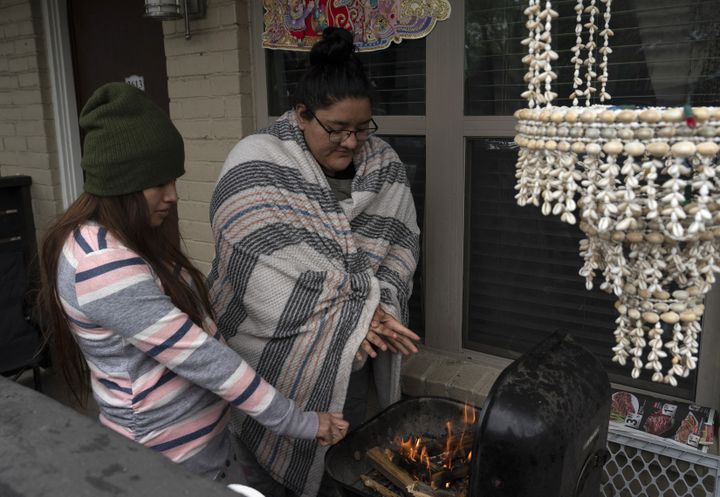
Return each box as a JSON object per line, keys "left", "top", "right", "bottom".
{"left": 209, "top": 28, "right": 419, "bottom": 497}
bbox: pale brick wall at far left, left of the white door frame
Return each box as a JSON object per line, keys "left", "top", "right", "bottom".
{"left": 0, "top": 0, "right": 61, "bottom": 235}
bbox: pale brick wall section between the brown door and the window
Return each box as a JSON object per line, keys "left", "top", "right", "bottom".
{"left": 163, "top": 0, "right": 254, "bottom": 273}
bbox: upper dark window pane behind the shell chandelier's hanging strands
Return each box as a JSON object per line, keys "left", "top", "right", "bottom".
{"left": 465, "top": 0, "right": 720, "bottom": 116}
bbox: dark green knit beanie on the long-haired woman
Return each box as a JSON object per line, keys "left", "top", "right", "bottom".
{"left": 80, "top": 83, "right": 185, "bottom": 197}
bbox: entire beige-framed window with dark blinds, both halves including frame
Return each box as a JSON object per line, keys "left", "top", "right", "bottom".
{"left": 253, "top": 0, "right": 720, "bottom": 408}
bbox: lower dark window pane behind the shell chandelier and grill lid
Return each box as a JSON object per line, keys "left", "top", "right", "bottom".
{"left": 464, "top": 138, "right": 697, "bottom": 399}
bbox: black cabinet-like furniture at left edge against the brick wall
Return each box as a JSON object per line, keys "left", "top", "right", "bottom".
{"left": 0, "top": 176, "right": 42, "bottom": 389}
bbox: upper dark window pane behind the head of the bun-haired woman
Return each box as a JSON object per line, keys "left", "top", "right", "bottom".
{"left": 265, "top": 38, "right": 425, "bottom": 116}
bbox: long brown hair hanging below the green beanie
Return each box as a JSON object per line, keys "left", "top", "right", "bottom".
{"left": 38, "top": 192, "right": 212, "bottom": 407}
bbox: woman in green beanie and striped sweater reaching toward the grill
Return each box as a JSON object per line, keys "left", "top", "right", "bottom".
{"left": 40, "top": 83, "right": 347, "bottom": 483}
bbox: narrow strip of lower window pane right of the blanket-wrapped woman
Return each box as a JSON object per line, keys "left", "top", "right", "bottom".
{"left": 381, "top": 136, "right": 425, "bottom": 337}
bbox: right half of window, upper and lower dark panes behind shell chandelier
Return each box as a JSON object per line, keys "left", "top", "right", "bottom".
{"left": 464, "top": 0, "right": 720, "bottom": 398}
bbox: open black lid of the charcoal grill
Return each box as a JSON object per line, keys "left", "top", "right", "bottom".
{"left": 469, "top": 333, "right": 610, "bottom": 497}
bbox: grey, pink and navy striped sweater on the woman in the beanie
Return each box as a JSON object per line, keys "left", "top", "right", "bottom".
{"left": 58, "top": 223, "right": 318, "bottom": 476}
